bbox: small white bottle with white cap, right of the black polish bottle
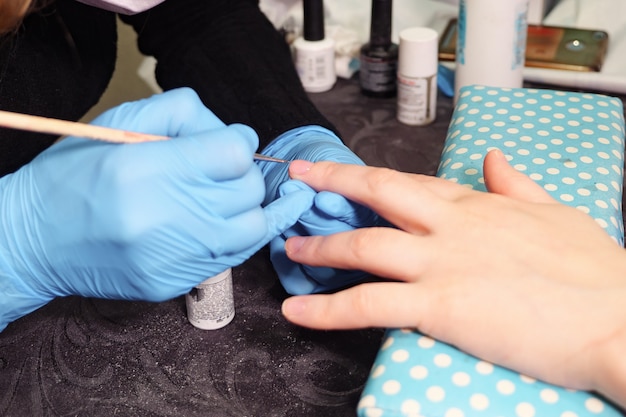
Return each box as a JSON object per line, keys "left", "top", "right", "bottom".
{"left": 397, "top": 27, "right": 439, "bottom": 126}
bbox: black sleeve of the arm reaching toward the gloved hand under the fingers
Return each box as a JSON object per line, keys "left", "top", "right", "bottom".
{"left": 121, "top": 0, "right": 334, "bottom": 147}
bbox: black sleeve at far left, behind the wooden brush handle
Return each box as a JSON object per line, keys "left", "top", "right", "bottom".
{"left": 0, "top": 0, "right": 117, "bottom": 176}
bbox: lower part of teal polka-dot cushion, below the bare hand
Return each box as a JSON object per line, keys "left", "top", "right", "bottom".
{"left": 358, "top": 330, "right": 622, "bottom": 417}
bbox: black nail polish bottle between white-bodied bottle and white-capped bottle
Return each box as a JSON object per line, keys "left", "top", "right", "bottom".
{"left": 359, "top": 0, "right": 398, "bottom": 97}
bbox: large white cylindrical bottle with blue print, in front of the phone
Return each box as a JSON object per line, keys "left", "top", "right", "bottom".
{"left": 455, "top": 0, "right": 529, "bottom": 101}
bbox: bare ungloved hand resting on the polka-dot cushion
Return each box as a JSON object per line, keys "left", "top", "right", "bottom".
{"left": 283, "top": 151, "right": 626, "bottom": 406}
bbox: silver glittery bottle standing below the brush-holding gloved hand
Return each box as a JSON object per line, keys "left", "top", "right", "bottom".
{"left": 185, "top": 268, "right": 235, "bottom": 330}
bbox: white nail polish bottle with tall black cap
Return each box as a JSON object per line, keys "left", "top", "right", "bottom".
{"left": 293, "top": 0, "right": 337, "bottom": 93}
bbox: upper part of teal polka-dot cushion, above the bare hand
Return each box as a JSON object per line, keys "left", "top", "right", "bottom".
{"left": 437, "top": 86, "right": 624, "bottom": 245}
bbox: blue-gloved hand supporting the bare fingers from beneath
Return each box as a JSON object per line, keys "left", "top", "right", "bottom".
{"left": 259, "top": 126, "right": 377, "bottom": 294}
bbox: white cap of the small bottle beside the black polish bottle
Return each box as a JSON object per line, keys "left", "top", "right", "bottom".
{"left": 398, "top": 27, "right": 439, "bottom": 78}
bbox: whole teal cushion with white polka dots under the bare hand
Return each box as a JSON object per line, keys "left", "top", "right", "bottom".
{"left": 357, "top": 86, "right": 624, "bottom": 417}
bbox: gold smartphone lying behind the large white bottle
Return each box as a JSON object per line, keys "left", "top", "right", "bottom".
{"left": 439, "top": 18, "right": 609, "bottom": 72}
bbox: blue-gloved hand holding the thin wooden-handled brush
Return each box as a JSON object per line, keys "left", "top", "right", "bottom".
{"left": 0, "top": 88, "right": 312, "bottom": 329}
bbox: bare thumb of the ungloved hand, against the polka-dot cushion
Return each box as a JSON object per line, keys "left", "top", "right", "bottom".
{"left": 483, "top": 149, "right": 554, "bottom": 203}
